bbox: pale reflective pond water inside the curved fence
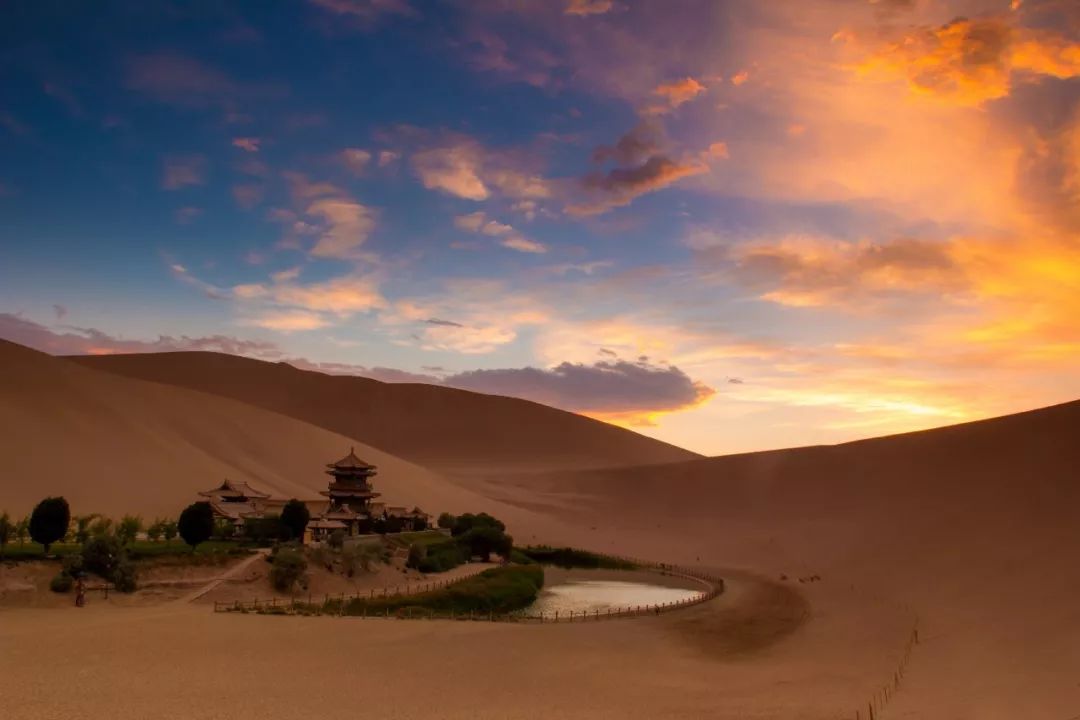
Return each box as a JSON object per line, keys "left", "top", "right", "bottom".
{"left": 526, "top": 580, "right": 701, "bottom": 615}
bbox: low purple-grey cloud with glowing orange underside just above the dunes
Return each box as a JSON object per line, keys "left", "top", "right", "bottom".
{"left": 444, "top": 361, "right": 715, "bottom": 423}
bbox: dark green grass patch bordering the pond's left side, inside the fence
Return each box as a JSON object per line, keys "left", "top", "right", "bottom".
{"left": 308, "top": 565, "right": 543, "bottom": 615}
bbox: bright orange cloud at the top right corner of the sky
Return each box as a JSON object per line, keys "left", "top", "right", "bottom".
{"left": 859, "top": 17, "right": 1080, "bottom": 105}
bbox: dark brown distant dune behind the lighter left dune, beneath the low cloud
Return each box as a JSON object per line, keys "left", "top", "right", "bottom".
{"left": 68, "top": 352, "right": 700, "bottom": 473}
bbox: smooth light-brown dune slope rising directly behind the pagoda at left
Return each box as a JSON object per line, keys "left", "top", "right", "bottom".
{"left": 0, "top": 341, "right": 540, "bottom": 526}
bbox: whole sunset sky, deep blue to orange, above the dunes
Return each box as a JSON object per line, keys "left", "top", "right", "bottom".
{"left": 0, "top": 0, "right": 1080, "bottom": 454}
